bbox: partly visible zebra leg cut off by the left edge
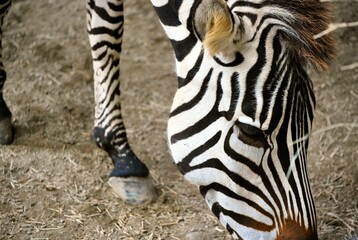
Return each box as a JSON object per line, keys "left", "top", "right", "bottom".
{"left": 0, "top": 0, "right": 13, "bottom": 145}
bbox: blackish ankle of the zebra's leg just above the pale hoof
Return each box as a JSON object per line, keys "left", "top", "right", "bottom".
{"left": 93, "top": 127, "right": 149, "bottom": 177}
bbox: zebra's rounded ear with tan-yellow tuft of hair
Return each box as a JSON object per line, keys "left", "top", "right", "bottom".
{"left": 194, "top": 0, "right": 243, "bottom": 56}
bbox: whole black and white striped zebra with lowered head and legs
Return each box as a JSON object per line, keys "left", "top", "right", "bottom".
{"left": 0, "top": 0, "right": 334, "bottom": 239}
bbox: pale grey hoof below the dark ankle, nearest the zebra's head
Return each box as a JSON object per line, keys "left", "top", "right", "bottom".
{"left": 108, "top": 176, "right": 157, "bottom": 204}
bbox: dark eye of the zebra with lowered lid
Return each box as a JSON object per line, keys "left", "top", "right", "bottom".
{"left": 237, "top": 122, "right": 267, "bottom": 147}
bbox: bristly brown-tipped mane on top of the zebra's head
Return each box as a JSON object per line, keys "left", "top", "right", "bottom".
{"left": 268, "top": 0, "right": 335, "bottom": 70}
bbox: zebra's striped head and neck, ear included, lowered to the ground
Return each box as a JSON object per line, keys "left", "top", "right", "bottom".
{"left": 152, "top": 0, "right": 329, "bottom": 239}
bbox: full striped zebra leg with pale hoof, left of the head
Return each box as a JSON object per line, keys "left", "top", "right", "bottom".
{"left": 87, "top": 0, "right": 156, "bottom": 204}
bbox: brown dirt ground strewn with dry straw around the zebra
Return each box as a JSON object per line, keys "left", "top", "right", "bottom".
{"left": 0, "top": 0, "right": 358, "bottom": 240}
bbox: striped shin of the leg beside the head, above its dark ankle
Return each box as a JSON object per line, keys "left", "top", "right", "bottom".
{"left": 87, "top": 0, "right": 128, "bottom": 149}
